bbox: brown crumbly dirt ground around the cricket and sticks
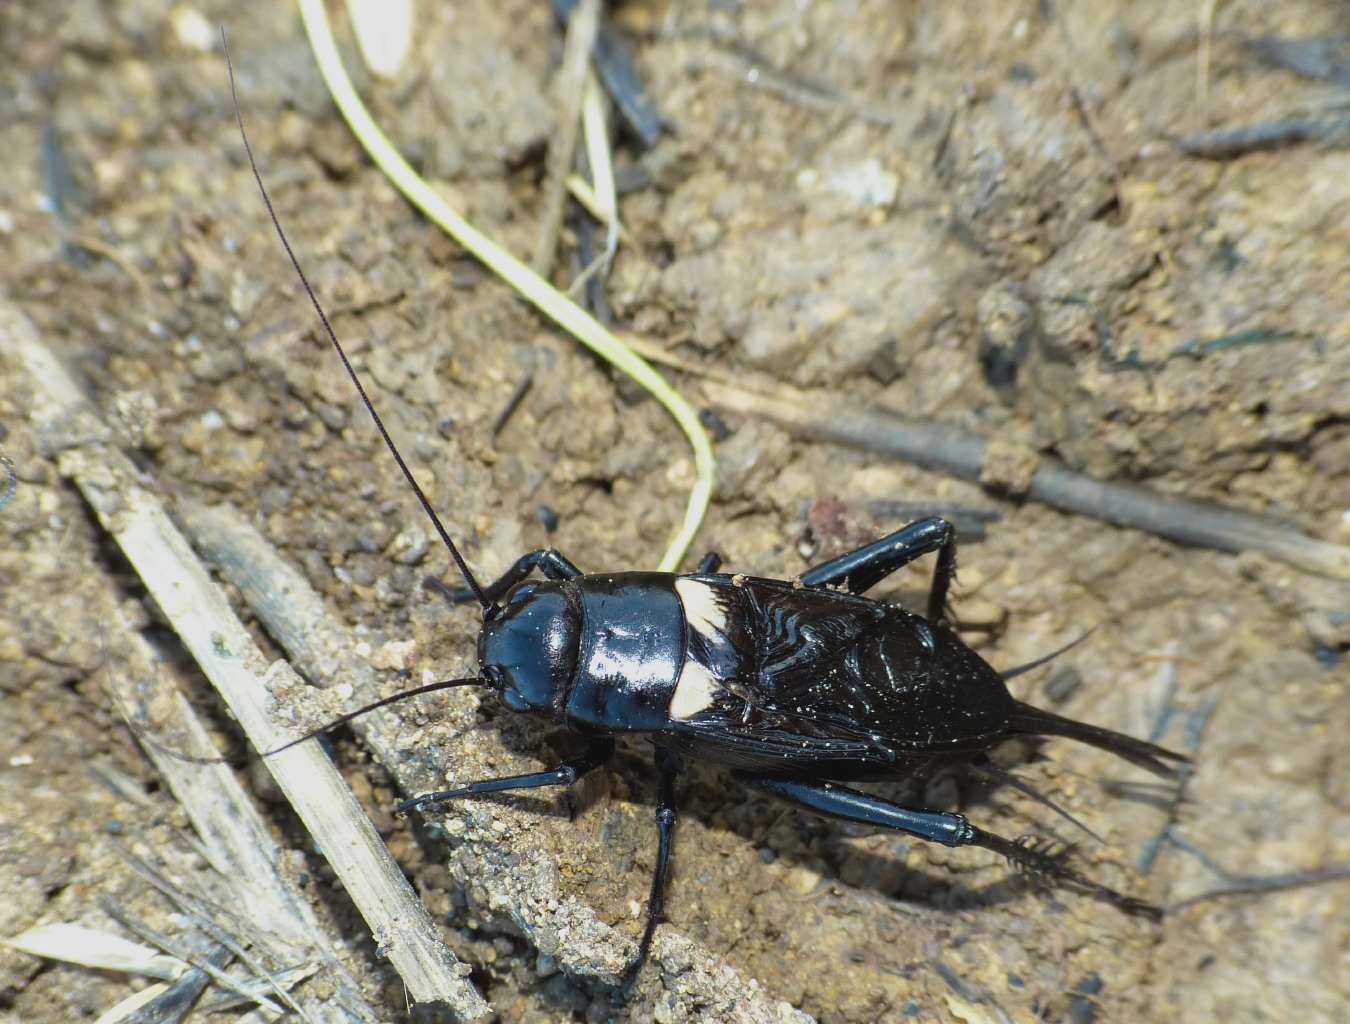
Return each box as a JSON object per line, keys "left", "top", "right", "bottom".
{"left": 0, "top": 0, "right": 1350, "bottom": 1024}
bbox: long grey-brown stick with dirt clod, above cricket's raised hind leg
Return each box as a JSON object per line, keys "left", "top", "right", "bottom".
{"left": 703, "top": 382, "right": 1350, "bottom": 580}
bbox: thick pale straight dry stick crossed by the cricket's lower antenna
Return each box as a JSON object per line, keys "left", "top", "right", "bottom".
{"left": 0, "top": 305, "right": 491, "bottom": 1020}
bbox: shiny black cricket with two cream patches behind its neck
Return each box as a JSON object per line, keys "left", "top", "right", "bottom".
{"left": 227, "top": 54, "right": 1187, "bottom": 984}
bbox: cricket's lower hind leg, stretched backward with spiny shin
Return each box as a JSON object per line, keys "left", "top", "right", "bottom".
{"left": 734, "top": 772, "right": 1162, "bottom": 920}
